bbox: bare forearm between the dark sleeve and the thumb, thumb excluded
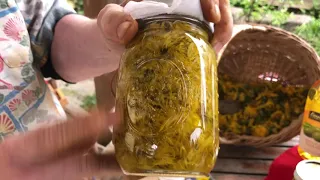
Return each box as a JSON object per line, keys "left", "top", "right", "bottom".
{"left": 51, "top": 14, "right": 123, "bottom": 82}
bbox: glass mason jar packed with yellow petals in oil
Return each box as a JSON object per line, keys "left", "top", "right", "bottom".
{"left": 113, "top": 15, "right": 219, "bottom": 177}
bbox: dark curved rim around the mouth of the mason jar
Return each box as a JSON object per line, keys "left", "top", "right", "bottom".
{"left": 137, "top": 14, "right": 213, "bottom": 41}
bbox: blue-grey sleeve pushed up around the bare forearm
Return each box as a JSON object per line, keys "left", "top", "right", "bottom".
{"left": 18, "top": 0, "right": 76, "bottom": 80}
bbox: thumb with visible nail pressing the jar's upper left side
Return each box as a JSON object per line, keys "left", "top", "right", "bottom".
{"left": 97, "top": 4, "right": 138, "bottom": 44}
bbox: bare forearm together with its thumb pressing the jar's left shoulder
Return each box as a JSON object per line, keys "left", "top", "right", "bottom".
{"left": 51, "top": 4, "right": 138, "bottom": 82}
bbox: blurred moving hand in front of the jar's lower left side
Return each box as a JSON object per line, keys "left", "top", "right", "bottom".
{"left": 0, "top": 113, "right": 122, "bottom": 180}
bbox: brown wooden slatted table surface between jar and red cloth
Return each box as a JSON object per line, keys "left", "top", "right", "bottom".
{"left": 212, "top": 136, "right": 299, "bottom": 180}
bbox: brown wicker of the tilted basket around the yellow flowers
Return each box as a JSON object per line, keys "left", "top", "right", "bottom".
{"left": 218, "top": 25, "right": 320, "bottom": 147}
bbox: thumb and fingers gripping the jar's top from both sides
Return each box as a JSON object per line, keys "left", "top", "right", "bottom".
{"left": 97, "top": 0, "right": 233, "bottom": 52}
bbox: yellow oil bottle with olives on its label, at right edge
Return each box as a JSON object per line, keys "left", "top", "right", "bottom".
{"left": 298, "top": 80, "right": 320, "bottom": 160}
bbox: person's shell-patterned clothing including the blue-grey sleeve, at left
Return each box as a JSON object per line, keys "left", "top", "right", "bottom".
{"left": 0, "top": 0, "right": 75, "bottom": 142}
